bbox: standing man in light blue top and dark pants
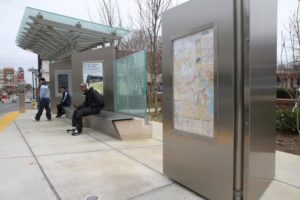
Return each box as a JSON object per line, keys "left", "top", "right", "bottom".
{"left": 34, "top": 77, "right": 51, "bottom": 121}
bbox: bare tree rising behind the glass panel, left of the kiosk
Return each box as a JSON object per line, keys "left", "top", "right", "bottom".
{"left": 135, "top": 0, "right": 172, "bottom": 112}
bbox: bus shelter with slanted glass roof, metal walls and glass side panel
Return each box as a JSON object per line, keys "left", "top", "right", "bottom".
{"left": 16, "top": 7, "right": 149, "bottom": 138}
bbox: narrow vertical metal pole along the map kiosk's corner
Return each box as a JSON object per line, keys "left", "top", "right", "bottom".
{"left": 233, "top": 0, "right": 244, "bottom": 200}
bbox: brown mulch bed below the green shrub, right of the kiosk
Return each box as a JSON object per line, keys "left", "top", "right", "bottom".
{"left": 276, "top": 131, "right": 300, "bottom": 155}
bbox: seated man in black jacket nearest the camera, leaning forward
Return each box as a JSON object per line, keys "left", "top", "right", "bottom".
{"left": 67, "top": 83, "right": 105, "bottom": 136}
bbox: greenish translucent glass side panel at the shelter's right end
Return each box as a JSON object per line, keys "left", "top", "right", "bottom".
{"left": 114, "top": 51, "right": 147, "bottom": 117}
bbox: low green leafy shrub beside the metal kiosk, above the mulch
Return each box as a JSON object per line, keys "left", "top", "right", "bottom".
{"left": 276, "top": 109, "right": 300, "bottom": 133}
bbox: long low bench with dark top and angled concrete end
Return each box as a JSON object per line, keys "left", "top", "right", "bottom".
{"left": 64, "top": 107, "right": 152, "bottom": 140}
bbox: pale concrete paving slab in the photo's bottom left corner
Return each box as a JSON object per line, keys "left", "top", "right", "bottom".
{"left": 0, "top": 157, "right": 56, "bottom": 200}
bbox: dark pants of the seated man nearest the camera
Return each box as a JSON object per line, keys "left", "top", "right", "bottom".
{"left": 72, "top": 107, "right": 100, "bottom": 133}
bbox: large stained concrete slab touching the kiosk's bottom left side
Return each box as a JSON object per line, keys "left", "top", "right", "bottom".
{"left": 38, "top": 150, "right": 171, "bottom": 200}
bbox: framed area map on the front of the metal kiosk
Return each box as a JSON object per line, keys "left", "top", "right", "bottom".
{"left": 173, "top": 28, "right": 214, "bottom": 138}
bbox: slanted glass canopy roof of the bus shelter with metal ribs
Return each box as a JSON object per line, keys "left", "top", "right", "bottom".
{"left": 16, "top": 7, "right": 128, "bottom": 60}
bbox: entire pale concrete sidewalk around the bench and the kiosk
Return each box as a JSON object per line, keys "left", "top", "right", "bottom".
{"left": 0, "top": 111, "right": 300, "bottom": 200}
